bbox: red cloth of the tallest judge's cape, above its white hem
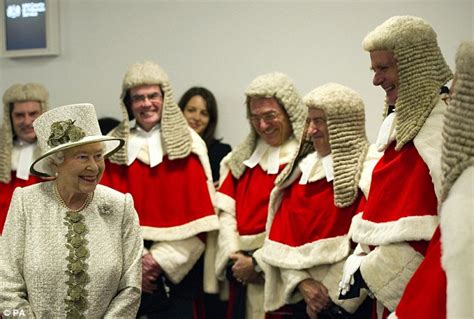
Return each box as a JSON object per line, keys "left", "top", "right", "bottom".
{"left": 362, "top": 142, "right": 438, "bottom": 223}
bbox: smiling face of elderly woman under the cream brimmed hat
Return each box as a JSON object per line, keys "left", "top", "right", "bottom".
{"left": 57, "top": 143, "right": 105, "bottom": 198}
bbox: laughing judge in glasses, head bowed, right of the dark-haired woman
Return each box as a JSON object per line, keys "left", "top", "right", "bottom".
{"left": 216, "top": 73, "right": 305, "bottom": 319}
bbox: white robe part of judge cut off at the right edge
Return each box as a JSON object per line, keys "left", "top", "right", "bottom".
{"left": 440, "top": 166, "right": 474, "bottom": 318}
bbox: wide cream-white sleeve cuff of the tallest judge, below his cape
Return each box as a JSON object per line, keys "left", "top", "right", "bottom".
{"left": 360, "top": 243, "right": 423, "bottom": 311}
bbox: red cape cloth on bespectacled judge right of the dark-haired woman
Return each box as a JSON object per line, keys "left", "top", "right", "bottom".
{"left": 219, "top": 165, "right": 284, "bottom": 235}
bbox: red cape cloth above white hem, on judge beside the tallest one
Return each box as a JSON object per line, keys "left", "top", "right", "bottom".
{"left": 269, "top": 178, "right": 365, "bottom": 247}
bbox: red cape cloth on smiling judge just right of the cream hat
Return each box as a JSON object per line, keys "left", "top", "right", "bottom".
{"left": 101, "top": 154, "right": 214, "bottom": 228}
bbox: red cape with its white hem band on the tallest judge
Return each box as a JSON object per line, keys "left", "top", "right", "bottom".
{"left": 351, "top": 141, "right": 438, "bottom": 318}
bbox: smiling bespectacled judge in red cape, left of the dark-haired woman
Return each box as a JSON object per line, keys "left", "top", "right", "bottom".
{"left": 102, "top": 62, "right": 219, "bottom": 318}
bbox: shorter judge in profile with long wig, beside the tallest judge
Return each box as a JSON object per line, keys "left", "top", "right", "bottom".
{"left": 262, "top": 83, "right": 381, "bottom": 318}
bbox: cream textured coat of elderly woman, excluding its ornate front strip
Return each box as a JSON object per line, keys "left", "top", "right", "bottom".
{"left": 0, "top": 182, "right": 142, "bottom": 319}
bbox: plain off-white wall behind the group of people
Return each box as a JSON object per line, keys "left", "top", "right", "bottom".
{"left": 0, "top": 0, "right": 474, "bottom": 146}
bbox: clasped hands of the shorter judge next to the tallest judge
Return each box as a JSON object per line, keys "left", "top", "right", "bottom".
{"left": 298, "top": 278, "right": 330, "bottom": 319}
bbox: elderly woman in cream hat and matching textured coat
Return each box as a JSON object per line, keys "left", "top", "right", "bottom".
{"left": 0, "top": 104, "right": 142, "bottom": 318}
